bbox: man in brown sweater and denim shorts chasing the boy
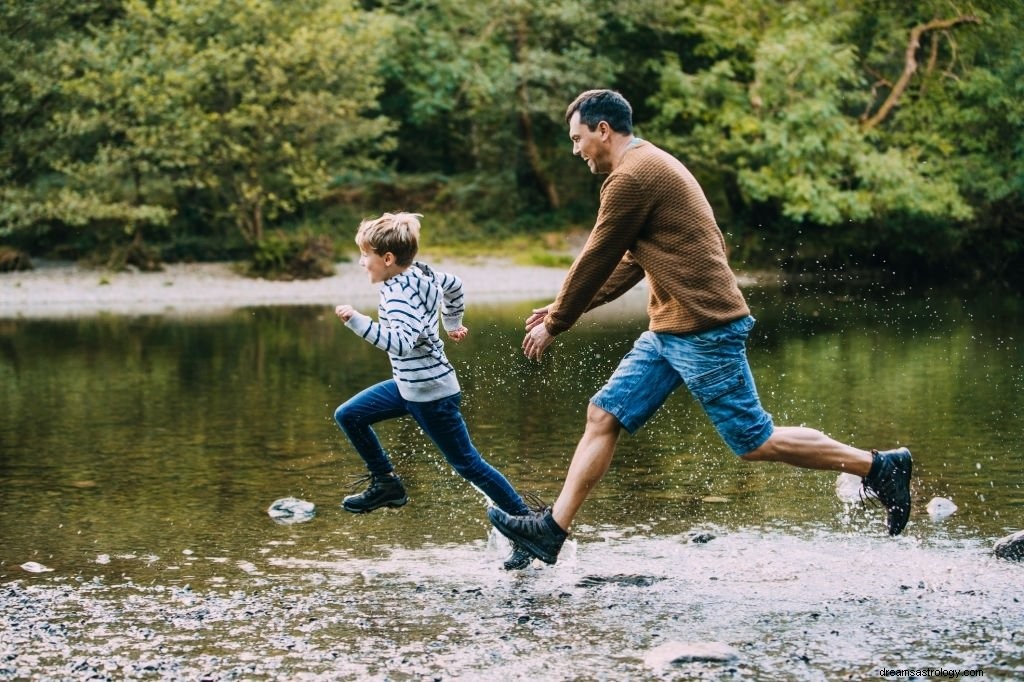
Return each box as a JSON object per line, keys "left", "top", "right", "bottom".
{"left": 487, "top": 90, "right": 912, "bottom": 563}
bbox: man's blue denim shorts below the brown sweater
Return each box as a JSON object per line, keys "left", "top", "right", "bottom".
{"left": 591, "top": 315, "right": 774, "bottom": 455}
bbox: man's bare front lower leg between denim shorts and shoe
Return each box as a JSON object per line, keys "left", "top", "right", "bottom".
{"left": 551, "top": 402, "right": 622, "bottom": 531}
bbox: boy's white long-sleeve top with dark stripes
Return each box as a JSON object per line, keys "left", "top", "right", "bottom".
{"left": 345, "top": 262, "right": 466, "bottom": 402}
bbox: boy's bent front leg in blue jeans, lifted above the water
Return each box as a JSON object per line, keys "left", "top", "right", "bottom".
{"left": 334, "top": 379, "right": 409, "bottom": 475}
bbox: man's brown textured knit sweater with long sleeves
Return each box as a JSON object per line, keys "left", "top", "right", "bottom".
{"left": 545, "top": 140, "right": 750, "bottom": 334}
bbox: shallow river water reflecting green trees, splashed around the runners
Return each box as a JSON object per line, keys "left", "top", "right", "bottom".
{"left": 0, "top": 278, "right": 1024, "bottom": 680}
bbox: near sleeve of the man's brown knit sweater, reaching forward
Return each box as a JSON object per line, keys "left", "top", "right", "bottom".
{"left": 544, "top": 173, "right": 648, "bottom": 335}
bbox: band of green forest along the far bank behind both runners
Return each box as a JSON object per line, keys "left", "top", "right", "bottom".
{"left": 0, "top": 0, "right": 1024, "bottom": 289}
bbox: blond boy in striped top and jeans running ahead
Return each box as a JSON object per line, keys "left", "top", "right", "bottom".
{"left": 334, "top": 213, "right": 532, "bottom": 570}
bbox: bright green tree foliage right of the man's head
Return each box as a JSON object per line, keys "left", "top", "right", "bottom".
{"left": 650, "top": 2, "right": 972, "bottom": 262}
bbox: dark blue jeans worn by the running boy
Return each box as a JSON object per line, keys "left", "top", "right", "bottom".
{"left": 334, "top": 379, "right": 529, "bottom": 515}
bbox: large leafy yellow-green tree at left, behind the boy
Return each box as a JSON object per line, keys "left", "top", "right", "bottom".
{"left": 11, "top": 0, "right": 392, "bottom": 256}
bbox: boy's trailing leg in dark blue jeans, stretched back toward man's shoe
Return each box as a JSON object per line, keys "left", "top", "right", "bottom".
{"left": 409, "top": 393, "right": 529, "bottom": 514}
